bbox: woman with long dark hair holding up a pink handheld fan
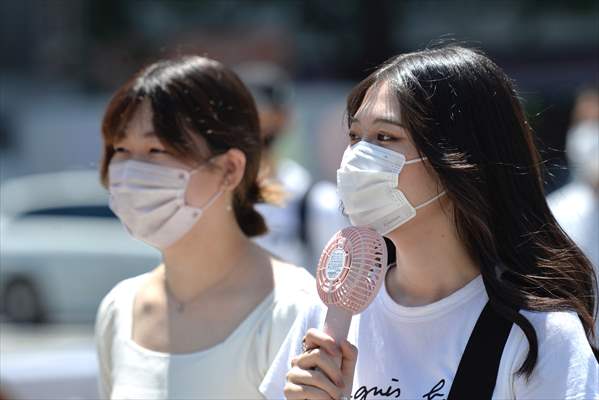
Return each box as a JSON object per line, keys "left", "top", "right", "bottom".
{"left": 261, "top": 45, "right": 599, "bottom": 400}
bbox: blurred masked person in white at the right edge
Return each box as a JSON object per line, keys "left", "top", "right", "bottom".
{"left": 548, "top": 88, "right": 599, "bottom": 345}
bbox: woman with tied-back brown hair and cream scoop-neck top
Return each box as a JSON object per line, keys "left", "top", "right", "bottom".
{"left": 96, "top": 56, "right": 314, "bottom": 399}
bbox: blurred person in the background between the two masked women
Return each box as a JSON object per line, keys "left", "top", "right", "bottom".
{"left": 234, "top": 61, "right": 349, "bottom": 273}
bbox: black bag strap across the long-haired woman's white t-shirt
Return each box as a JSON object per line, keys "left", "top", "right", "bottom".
{"left": 447, "top": 302, "right": 513, "bottom": 400}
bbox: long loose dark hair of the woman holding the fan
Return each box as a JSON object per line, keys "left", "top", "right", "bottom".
{"left": 347, "top": 44, "right": 597, "bottom": 376}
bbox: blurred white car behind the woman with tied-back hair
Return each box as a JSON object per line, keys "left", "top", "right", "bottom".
{"left": 0, "top": 170, "right": 160, "bottom": 322}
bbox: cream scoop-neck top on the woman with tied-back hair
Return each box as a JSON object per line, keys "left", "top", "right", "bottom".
{"left": 96, "top": 264, "right": 317, "bottom": 399}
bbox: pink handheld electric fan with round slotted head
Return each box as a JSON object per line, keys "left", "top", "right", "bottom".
{"left": 316, "top": 227, "right": 387, "bottom": 343}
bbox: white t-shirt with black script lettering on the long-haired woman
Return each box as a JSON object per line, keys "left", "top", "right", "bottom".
{"left": 260, "top": 275, "right": 599, "bottom": 400}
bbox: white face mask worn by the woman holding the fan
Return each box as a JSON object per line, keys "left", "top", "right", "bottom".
{"left": 337, "top": 141, "right": 445, "bottom": 235}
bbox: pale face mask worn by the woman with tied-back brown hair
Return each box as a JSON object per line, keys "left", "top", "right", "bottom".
{"left": 108, "top": 160, "right": 223, "bottom": 250}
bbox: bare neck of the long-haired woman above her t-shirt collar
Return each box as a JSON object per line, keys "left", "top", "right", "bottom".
{"left": 386, "top": 203, "right": 480, "bottom": 306}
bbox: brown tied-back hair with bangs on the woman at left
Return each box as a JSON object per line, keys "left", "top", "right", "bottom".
{"left": 100, "top": 55, "right": 280, "bottom": 237}
